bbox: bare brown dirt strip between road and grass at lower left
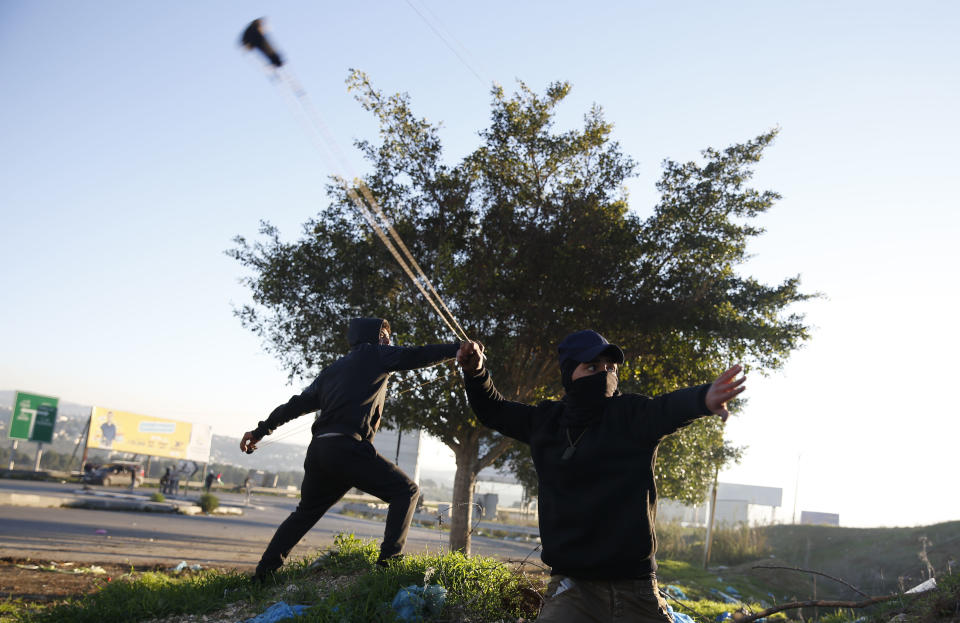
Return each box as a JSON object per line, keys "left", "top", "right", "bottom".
{"left": 0, "top": 557, "right": 232, "bottom": 603}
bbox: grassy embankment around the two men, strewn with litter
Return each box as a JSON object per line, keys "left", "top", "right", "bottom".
{"left": 0, "top": 522, "right": 960, "bottom": 623}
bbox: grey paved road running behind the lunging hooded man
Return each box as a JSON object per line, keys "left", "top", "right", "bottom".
{"left": 0, "top": 480, "right": 540, "bottom": 570}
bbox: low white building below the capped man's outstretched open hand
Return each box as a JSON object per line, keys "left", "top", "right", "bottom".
{"left": 657, "top": 482, "right": 786, "bottom": 526}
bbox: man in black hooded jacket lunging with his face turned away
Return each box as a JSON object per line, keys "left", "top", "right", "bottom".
{"left": 240, "top": 318, "right": 459, "bottom": 580}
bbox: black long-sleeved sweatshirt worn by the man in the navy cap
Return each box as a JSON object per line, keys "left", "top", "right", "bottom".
{"left": 465, "top": 371, "right": 710, "bottom": 580}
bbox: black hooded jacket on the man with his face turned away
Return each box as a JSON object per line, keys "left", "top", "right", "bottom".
{"left": 253, "top": 318, "right": 459, "bottom": 441}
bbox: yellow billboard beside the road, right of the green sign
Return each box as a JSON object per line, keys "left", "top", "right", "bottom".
{"left": 87, "top": 407, "right": 193, "bottom": 459}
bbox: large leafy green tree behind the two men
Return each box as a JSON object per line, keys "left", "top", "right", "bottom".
{"left": 228, "top": 72, "right": 807, "bottom": 551}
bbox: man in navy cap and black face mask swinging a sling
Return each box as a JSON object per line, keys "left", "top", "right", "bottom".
{"left": 457, "top": 331, "right": 745, "bottom": 623}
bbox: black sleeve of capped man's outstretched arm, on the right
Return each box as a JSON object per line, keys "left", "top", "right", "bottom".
{"left": 630, "top": 384, "right": 710, "bottom": 444}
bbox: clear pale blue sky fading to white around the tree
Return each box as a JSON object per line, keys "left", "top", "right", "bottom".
{"left": 0, "top": 0, "right": 960, "bottom": 526}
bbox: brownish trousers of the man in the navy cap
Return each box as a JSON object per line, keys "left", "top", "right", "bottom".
{"left": 537, "top": 574, "right": 673, "bottom": 623}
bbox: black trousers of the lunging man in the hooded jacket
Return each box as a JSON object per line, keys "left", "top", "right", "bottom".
{"left": 257, "top": 435, "right": 420, "bottom": 574}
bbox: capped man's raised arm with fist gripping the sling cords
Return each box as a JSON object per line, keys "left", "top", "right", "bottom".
{"left": 457, "top": 342, "right": 537, "bottom": 443}
